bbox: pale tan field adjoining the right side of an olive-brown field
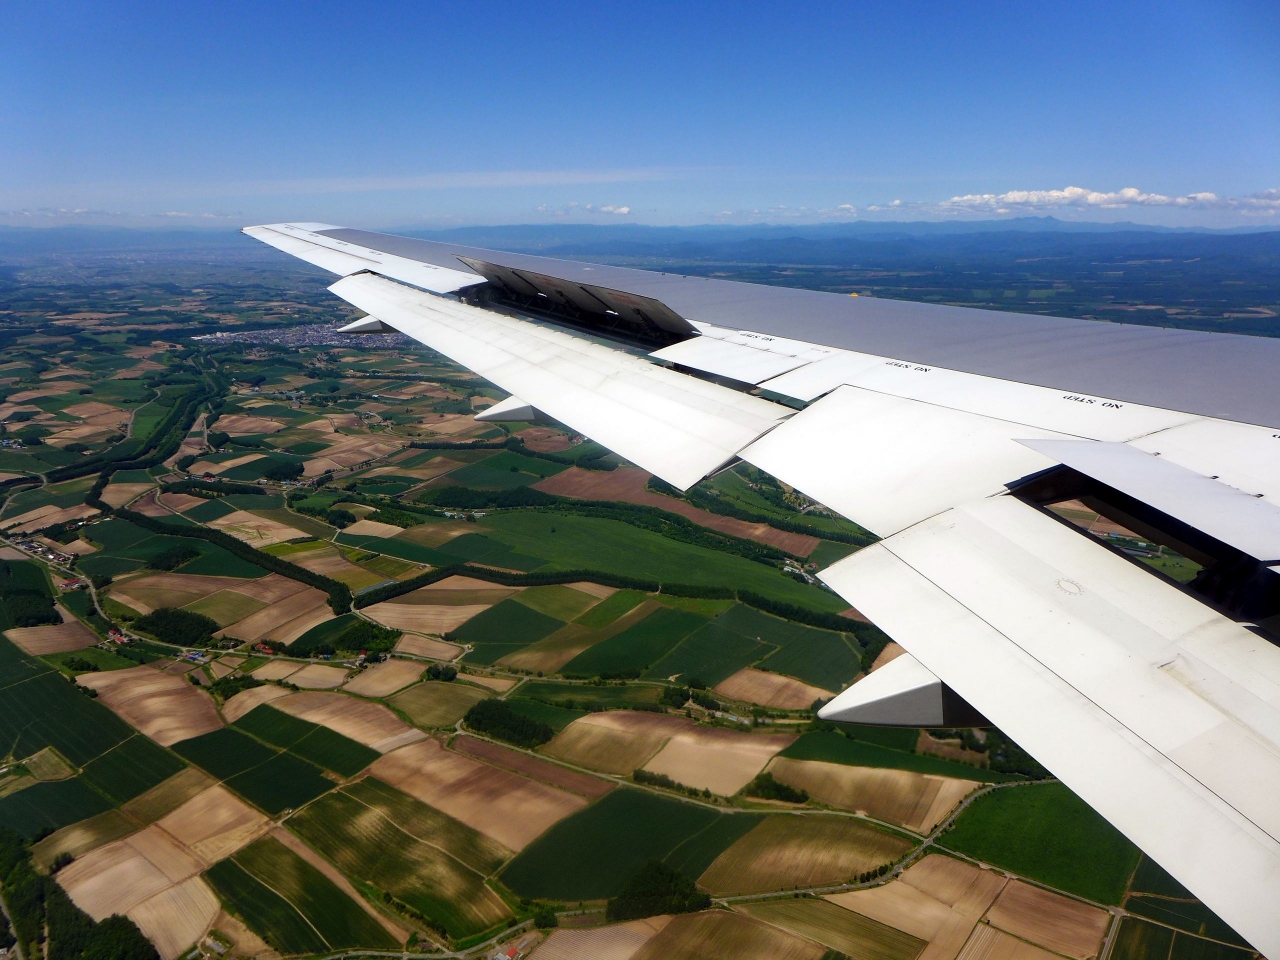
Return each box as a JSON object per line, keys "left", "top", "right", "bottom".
{"left": 645, "top": 726, "right": 795, "bottom": 796}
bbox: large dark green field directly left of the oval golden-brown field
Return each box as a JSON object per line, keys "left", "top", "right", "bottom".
{"left": 502, "top": 787, "right": 755, "bottom": 900}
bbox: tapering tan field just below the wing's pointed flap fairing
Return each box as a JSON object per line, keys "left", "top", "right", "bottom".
{"left": 769, "top": 756, "right": 982, "bottom": 833}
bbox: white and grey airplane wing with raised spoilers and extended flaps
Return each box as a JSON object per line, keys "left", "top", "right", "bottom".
{"left": 246, "top": 224, "right": 1280, "bottom": 957}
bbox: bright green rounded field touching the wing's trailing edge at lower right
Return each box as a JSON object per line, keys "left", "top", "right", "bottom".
{"left": 940, "top": 783, "right": 1138, "bottom": 905}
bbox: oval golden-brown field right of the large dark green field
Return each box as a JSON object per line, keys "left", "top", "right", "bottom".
{"left": 698, "top": 814, "right": 913, "bottom": 895}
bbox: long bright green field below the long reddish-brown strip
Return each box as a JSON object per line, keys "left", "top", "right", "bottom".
{"left": 484, "top": 509, "right": 849, "bottom": 612}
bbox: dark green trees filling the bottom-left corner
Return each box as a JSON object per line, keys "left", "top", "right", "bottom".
{"left": 0, "top": 827, "right": 159, "bottom": 960}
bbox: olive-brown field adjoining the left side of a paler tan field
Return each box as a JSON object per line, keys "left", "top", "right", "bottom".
{"left": 543, "top": 710, "right": 694, "bottom": 777}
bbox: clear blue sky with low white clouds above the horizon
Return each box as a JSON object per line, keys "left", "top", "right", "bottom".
{"left": 0, "top": 0, "right": 1280, "bottom": 227}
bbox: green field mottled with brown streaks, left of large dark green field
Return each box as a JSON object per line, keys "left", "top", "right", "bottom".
{"left": 288, "top": 787, "right": 511, "bottom": 938}
